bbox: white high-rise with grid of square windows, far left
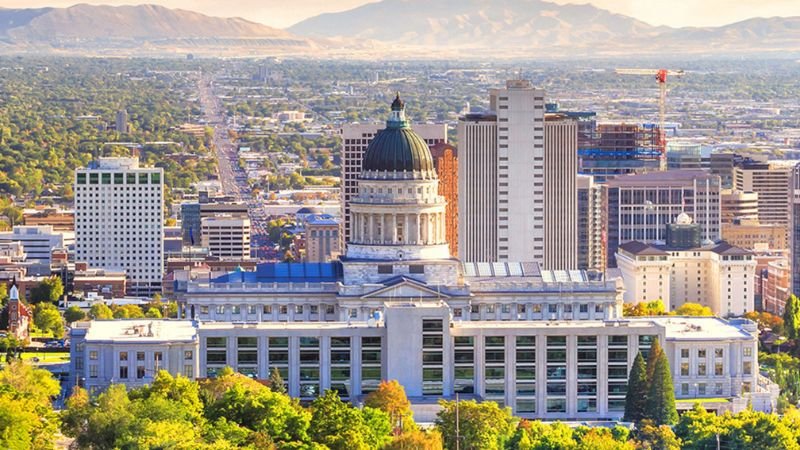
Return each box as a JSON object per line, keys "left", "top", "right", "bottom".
{"left": 75, "top": 158, "right": 164, "bottom": 295}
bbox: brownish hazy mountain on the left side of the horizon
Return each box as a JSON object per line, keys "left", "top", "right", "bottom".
{"left": 0, "top": 4, "right": 316, "bottom": 54}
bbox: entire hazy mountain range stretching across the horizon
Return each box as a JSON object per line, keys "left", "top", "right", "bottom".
{"left": 0, "top": 0, "right": 800, "bottom": 57}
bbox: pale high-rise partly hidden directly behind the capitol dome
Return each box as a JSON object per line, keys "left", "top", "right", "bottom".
{"left": 339, "top": 123, "right": 447, "bottom": 249}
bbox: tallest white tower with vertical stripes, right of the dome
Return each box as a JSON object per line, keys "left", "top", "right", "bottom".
{"left": 458, "top": 80, "right": 578, "bottom": 269}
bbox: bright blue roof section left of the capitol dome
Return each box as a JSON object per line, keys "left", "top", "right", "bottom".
{"left": 212, "top": 262, "right": 342, "bottom": 283}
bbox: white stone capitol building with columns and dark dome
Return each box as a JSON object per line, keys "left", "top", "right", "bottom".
{"left": 71, "top": 96, "right": 777, "bottom": 421}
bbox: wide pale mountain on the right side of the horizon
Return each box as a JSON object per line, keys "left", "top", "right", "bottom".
{"left": 288, "top": 0, "right": 800, "bottom": 56}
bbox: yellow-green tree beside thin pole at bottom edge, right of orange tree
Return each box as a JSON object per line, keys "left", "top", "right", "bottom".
{"left": 436, "top": 400, "right": 517, "bottom": 450}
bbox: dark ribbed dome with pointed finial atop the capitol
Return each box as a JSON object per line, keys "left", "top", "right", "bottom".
{"left": 362, "top": 94, "right": 434, "bottom": 173}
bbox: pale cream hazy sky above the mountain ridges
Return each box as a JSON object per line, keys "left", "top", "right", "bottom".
{"left": 6, "top": 0, "right": 800, "bottom": 28}
